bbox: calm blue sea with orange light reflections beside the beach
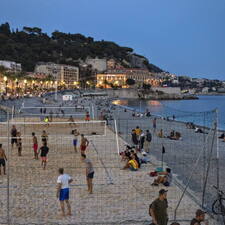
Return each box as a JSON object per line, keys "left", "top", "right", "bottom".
{"left": 113, "top": 96, "right": 225, "bottom": 130}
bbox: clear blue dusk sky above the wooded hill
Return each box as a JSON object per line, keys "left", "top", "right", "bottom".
{"left": 0, "top": 0, "right": 225, "bottom": 80}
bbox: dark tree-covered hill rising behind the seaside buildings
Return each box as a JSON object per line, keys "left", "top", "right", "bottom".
{"left": 0, "top": 23, "right": 162, "bottom": 72}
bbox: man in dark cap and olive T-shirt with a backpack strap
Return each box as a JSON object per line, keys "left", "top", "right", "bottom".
{"left": 149, "top": 189, "right": 168, "bottom": 225}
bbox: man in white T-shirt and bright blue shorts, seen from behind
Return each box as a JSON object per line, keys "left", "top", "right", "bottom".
{"left": 56, "top": 168, "right": 73, "bottom": 216}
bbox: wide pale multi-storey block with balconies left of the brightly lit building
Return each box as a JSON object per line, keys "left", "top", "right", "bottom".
{"left": 35, "top": 63, "right": 79, "bottom": 85}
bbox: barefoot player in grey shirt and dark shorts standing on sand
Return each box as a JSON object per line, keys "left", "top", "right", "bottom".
{"left": 81, "top": 154, "right": 95, "bottom": 194}
